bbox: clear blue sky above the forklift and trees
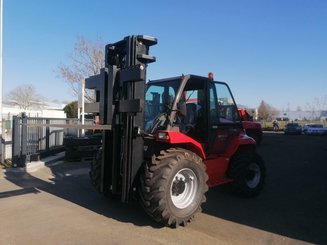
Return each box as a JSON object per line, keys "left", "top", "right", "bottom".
{"left": 3, "top": 0, "right": 327, "bottom": 109}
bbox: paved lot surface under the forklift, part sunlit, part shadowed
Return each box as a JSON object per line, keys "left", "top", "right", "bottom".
{"left": 0, "top": 133, "right": 327, "bottom": 245}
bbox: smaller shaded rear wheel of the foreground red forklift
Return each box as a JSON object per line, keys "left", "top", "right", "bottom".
{"left": 228, "top": 153, "right": 266, "bottom": 197}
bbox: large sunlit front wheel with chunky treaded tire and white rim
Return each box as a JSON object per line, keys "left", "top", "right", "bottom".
{"left": 138, "top": 148, "right": 208, "bottom": 227}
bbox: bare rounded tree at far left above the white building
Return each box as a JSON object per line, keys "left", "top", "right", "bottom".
{"left": 4, "top": 84, "right": 45, "bottom": 110}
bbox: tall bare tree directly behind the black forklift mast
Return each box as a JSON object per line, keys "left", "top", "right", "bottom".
{"left": 58, "top": 37, "right": 104, "bottom": 101}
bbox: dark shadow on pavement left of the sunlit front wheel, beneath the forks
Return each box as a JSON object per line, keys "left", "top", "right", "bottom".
{"left": 0, "top": 162, "right": 161, "bottom": 228}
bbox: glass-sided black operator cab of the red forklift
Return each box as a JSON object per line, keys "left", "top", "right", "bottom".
{"left": 145, "top": 75, "right": 242, "bottom": 154}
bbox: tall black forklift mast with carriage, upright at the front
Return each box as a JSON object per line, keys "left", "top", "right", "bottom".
{"left": 85, "top": 35, "right": 157, "bottom": 202}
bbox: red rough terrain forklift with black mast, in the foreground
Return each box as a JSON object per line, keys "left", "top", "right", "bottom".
{"left": 86, "top": 35, "right": 265, "bottom": 227}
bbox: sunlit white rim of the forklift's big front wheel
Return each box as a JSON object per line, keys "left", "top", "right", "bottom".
{"left": 170, "top": 168, "right": 198, "bottom": 209}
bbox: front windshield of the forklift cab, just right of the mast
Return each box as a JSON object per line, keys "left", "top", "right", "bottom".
{"left": 144, "top": 79, "right": 181, "bottom": 133}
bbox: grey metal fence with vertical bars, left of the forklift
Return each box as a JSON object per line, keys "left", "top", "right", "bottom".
{"left": 12, "top": 113, "right": 93, "bottom": 167}
